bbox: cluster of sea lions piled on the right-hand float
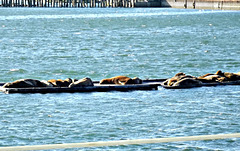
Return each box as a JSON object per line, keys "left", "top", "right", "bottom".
{"left": 162, "top": 70, "right": 240, "bottom": 88}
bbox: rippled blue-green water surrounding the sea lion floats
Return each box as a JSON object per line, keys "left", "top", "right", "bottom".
{"left": 0, "top": 8, "right": 240, "bottom": 151}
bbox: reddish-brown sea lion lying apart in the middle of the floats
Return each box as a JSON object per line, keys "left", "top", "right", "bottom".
{"left": 99, "top": 76, "right": 142, "bottom": 85}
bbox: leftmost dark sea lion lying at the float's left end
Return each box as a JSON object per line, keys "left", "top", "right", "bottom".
{"left": 3, "top": 79, "right": 48, "bottom": 88}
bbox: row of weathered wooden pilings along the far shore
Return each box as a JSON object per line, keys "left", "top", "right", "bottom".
{"left": 0, "top": 0, "right": 137, "bottom": 8}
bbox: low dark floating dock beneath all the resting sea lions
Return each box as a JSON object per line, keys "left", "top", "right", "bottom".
{"left": 0, "top": 79, "right": 240, "bottom": 94}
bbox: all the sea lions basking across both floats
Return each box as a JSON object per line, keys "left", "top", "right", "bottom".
{"left": 3, "top": 70, "right": 240, "bottom": 88}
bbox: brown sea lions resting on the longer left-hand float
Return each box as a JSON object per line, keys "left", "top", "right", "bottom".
{"left": 3, "top": 76, "right": 142, "bottom": 88}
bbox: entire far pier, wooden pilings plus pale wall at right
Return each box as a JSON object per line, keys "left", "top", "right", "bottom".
{"left": 0, "top": 0, "right": 240, "bottom": 10}
